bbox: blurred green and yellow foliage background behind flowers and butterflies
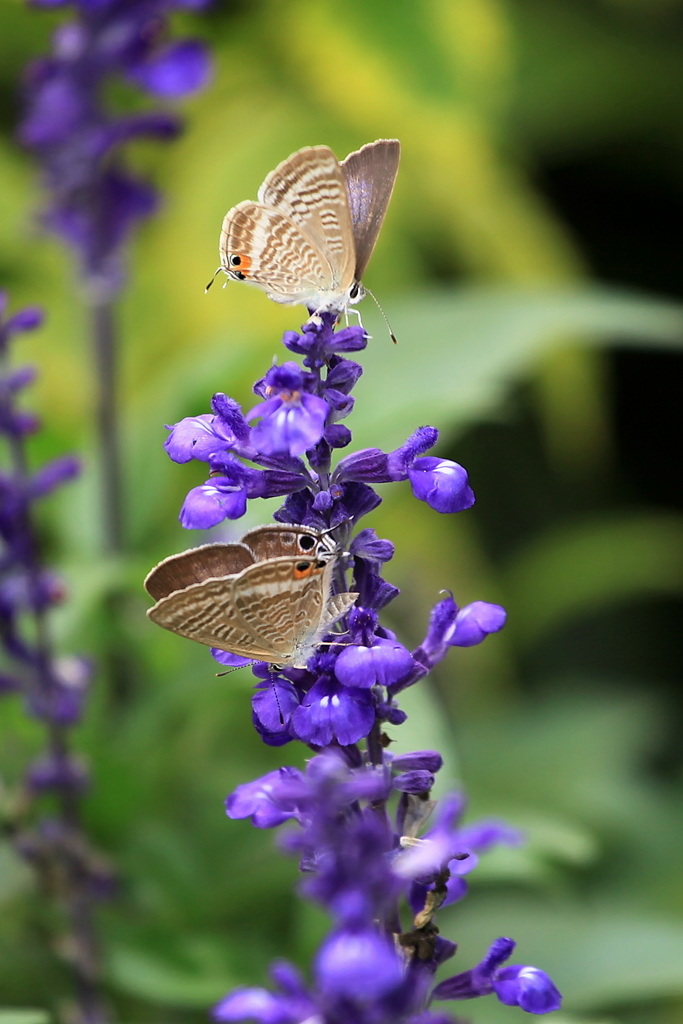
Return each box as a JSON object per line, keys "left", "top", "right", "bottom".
{"left": 0, "top": 0, "right": 683, "bottom": 1024}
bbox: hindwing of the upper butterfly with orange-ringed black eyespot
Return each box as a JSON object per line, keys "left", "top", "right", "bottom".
{"left": 219, "top": 200, "right": 333, "bottom": 303}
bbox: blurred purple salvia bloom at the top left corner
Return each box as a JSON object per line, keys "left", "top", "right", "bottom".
{"left": 19, "top": 0, "right": 210, "bottom": 298}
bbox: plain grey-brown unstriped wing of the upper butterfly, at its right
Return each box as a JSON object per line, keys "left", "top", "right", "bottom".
{"left": 341, "top": 138, "right": 400, "bottom": 281}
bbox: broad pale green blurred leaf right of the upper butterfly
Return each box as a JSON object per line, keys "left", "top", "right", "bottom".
{"left": 353, "top": 288, "right": 683, "bottom": 449}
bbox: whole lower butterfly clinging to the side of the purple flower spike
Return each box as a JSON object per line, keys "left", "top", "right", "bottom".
{"left": 144, "top": 523, "right": 358, "bottom": 669}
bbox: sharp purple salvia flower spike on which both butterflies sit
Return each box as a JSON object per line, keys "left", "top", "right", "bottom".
{"left": 158, "top": 314, "right": 560, "bottom": 1024}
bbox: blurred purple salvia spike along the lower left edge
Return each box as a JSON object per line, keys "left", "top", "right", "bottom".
{"left": 0, "top": 292, "right": 114, "bottom": 1024}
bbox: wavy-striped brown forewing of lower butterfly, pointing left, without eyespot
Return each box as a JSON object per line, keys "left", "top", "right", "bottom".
{"left": 147, "top": 577, "right": 273, "bottom": 662}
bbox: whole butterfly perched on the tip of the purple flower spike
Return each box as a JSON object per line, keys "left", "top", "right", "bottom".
{"left": 209, "top": 138, "right": 400, "bottom": 315}
